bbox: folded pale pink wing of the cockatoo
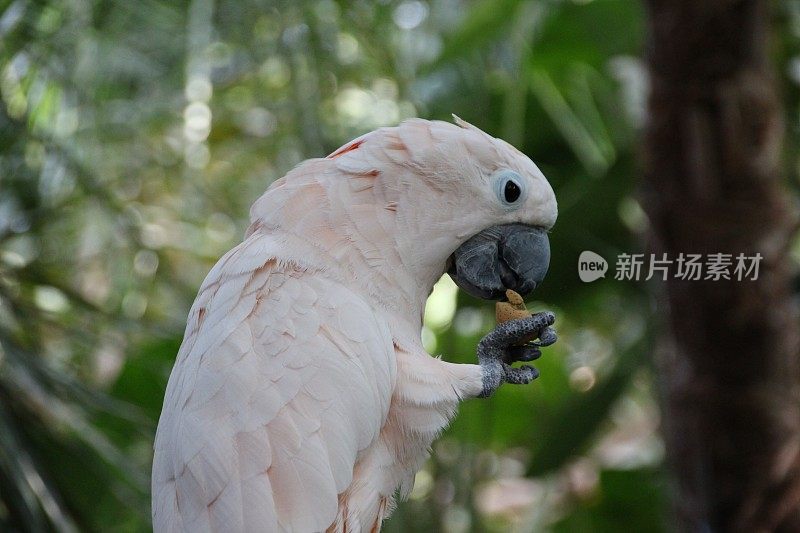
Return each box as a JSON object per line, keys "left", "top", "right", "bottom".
{"left": 153, "top": 233, "right": 396, "bottom": 532}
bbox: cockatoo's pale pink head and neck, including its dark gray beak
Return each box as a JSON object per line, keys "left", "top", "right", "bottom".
{"left": 250, "top": 118, "right": 557, "bottom": 304}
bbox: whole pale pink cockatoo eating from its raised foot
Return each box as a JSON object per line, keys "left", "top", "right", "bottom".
{"left": 152, "top": 117, "right": 557, "bottom": 533}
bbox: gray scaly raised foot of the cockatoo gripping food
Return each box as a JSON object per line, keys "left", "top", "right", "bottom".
{"left": 478, "top": 311, "right": 556, "bottom": 398}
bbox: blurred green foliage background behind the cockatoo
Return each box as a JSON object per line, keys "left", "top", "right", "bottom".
{"left": 0, "top": 0, "right": 800, "bottom": 532}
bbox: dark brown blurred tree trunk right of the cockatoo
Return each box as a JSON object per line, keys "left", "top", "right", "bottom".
{"left": 643, "top": 0, "right": 800, "bottom": 532}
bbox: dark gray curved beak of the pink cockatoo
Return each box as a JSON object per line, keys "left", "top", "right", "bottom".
{"left": 447, "top": 224, "right": 550, "bottom": 300}
